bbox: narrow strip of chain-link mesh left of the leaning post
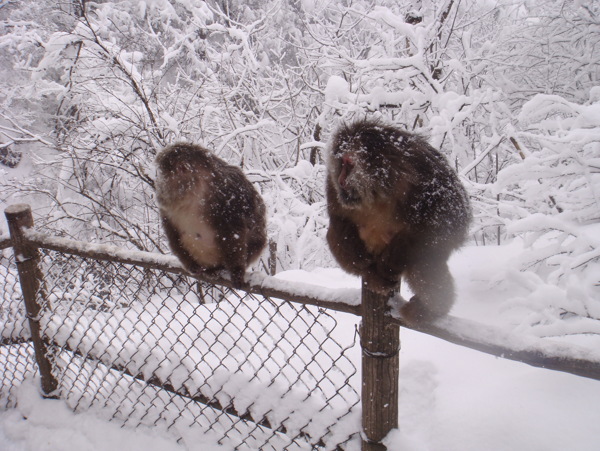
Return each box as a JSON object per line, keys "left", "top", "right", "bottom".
{"left": 0, "top": 249, "right": 36, "bottom": 408}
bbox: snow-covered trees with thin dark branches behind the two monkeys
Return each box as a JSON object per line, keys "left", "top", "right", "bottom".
{"left": 0, "top": 0, "right": 598, "bottom": 294}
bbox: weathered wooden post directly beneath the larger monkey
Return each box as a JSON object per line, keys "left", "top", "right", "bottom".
{"left": 360, "top": 282, "right": 400, "bottom": 451}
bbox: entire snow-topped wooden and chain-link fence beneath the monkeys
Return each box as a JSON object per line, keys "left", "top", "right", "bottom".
{"left": 0, "top": 206, "right": 600, "bottom": 450}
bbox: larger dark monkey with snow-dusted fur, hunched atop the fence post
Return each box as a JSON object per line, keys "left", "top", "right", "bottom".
{"left": 327, "top": 120, "right": 471, "bottom": 321}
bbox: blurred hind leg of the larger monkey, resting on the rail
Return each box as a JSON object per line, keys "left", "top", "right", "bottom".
{"left": 400, "top": 257, "right": 454, "bottom": 322}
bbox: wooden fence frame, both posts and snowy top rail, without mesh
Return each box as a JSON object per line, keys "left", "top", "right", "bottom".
{"left": 0, "top": 204, "right": 600, "bottom": 451}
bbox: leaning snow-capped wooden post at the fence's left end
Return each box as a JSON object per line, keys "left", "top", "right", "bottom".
{"left": 4, "top": 204, "right": 58, "bottom": 398}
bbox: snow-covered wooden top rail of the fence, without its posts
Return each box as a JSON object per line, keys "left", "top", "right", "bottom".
{"left": 25, "top": 229, "right": 600, "bottom": 380}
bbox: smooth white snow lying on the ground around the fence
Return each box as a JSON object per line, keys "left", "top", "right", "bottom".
{"left": 0, "top": 244, "right": 600, "bottom": 451}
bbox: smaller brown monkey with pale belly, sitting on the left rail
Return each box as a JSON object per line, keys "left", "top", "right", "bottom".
{"left": 156, "top": 143, "right": 266, "bottom": 287}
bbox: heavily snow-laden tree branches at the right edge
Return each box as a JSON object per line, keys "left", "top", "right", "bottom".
{"left": 495, "top": 87, "right": 600, "bottom": 335}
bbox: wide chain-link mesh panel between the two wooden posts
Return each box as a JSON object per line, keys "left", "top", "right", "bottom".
{"left": 2, "top": 250, "right": 360, "bottom": 450}
